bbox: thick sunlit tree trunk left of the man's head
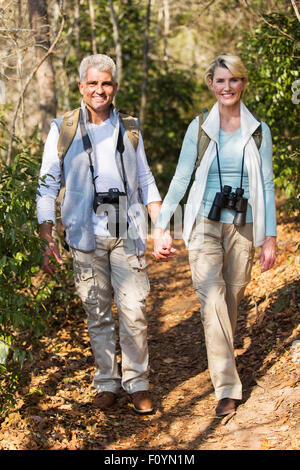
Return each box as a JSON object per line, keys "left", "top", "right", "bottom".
{"left": 28, "top": 0, "right": 56, "bottom": 139}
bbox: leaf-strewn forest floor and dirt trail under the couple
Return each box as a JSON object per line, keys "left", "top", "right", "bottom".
{"left": 0, "top": 215, "right": 300, "bottom": 451}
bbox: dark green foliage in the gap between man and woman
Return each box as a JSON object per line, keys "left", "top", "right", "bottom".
{"left": 144, "top": 69, "right": 198, "bottom": 196}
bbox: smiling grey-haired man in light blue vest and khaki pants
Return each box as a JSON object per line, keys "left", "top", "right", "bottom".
{"left": 37, "top": 54, "right": 166, "bottom": 413}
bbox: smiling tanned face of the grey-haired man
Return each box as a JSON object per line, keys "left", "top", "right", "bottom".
{"left": 78, "top": 67, "right": 118, "bottom": 117}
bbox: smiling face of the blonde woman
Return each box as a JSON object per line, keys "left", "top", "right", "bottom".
{"left": 210, "top": 67, "right": 247, "bottom": 106}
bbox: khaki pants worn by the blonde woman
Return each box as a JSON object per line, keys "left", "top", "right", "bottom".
{"left": 189, "top": 216, "right": 254, "bottom": 400}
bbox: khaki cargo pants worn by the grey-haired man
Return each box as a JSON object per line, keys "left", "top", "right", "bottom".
{"left": 71, "top": 236, "right": 150, "bottom": 393}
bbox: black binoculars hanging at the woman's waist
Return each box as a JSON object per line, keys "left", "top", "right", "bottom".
{"left": 208, "top": 186, "right": 248, "bottom": 227}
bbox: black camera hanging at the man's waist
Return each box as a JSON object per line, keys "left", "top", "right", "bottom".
{"left": 93, "top": 188, "right": 128, "bottom": 238}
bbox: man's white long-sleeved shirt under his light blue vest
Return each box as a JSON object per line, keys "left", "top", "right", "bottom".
{"left": 37, "top": 119, "right": 161, "bottom": 237}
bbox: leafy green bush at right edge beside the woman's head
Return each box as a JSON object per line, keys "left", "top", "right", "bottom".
{"left": 240, "top": 13, "right": 300, "bottom": 211}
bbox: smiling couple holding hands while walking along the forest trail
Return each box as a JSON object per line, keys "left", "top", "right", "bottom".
{"left": 37, "top": 54, "right": 276, "bottom": 416}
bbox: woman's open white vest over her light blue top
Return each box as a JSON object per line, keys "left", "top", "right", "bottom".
{"left": 183, "top": 102, "right": 265, "bottom": 247}
